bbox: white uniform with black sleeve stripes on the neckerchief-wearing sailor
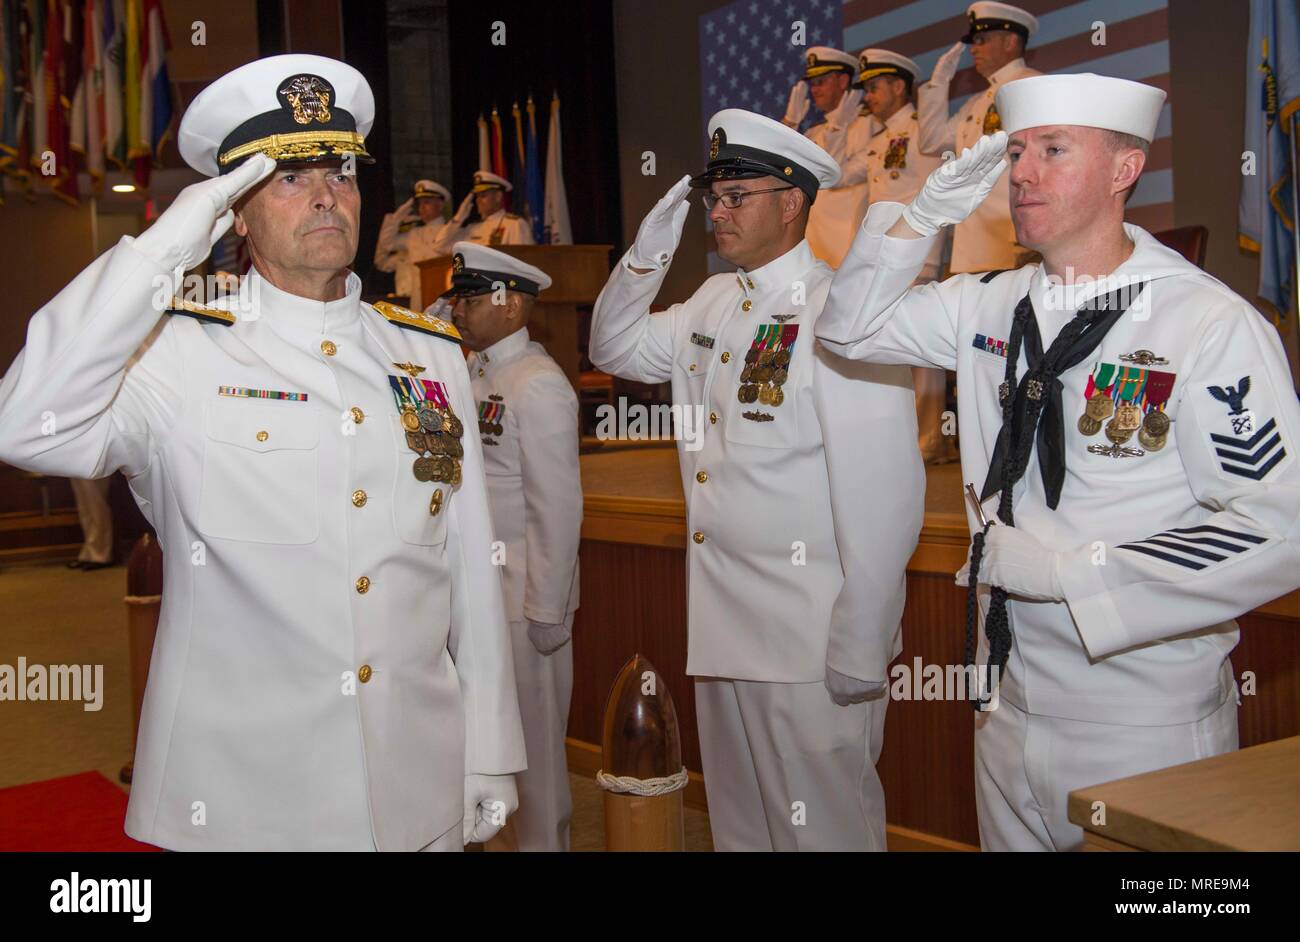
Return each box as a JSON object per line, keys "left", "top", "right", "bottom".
{"left": 818, "top": 203, "right": 1300, "bottom": 850}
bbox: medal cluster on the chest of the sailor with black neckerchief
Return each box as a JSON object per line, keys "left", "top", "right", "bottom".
{"left": 1079, "top": 364, "right": 1174, "bottom": 451}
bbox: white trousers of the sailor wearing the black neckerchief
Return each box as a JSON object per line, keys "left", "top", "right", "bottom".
{"left": 975, "top": 695, "right": 1236, "bottom": 851}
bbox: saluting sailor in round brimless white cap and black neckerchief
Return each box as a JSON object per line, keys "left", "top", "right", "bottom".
{"left": 818, "top": 74, "right": 1300, "bottom": 850}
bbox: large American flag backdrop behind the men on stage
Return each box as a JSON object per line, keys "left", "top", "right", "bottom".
{"left": 699, "top": 0, "right": 1174, "bottom": 231}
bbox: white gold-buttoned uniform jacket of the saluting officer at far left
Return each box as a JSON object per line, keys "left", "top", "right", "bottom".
{"left": 0, "top": 245, "right": 524, "bottom": 850}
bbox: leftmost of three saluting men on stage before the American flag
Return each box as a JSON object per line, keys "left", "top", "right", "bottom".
{"left": 784, "top": 45, "right": 867, "bottom": 268}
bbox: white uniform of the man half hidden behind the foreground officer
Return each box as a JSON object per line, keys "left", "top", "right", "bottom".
{"left": 469, "top": 327, "right": 582, "bottom": 851}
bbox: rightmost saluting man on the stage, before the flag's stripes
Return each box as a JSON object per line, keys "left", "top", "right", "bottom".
{"left": 917, "top": 1, "right": 1041, "bottom": 274}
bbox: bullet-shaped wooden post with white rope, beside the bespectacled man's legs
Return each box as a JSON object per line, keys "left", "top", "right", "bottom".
{"left": 601, "top": 655, "right": 686, "bottom": 851}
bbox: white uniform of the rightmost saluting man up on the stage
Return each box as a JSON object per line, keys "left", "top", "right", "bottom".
{"left": 917, "top": 58, "right": 1043, "bottom": 271}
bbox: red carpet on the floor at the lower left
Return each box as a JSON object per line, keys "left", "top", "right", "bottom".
{"left": 0, "top": 772, "right": 159, "bottom": 851}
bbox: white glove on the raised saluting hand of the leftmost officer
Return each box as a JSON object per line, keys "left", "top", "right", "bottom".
{"left": 135, "top": 153, "right": 276, "bottom": 274}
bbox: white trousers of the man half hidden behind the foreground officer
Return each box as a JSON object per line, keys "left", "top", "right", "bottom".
{"left": 510, "top": 613, "right": 573, "bottom": 851}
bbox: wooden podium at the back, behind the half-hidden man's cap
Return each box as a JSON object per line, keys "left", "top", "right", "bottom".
{"left": 417, "top": 246, "right": 612, "bottom": 390}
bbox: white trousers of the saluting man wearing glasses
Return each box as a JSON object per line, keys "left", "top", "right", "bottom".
{"left": 696, "top": 678, "right": 889, "bottom": 851}
